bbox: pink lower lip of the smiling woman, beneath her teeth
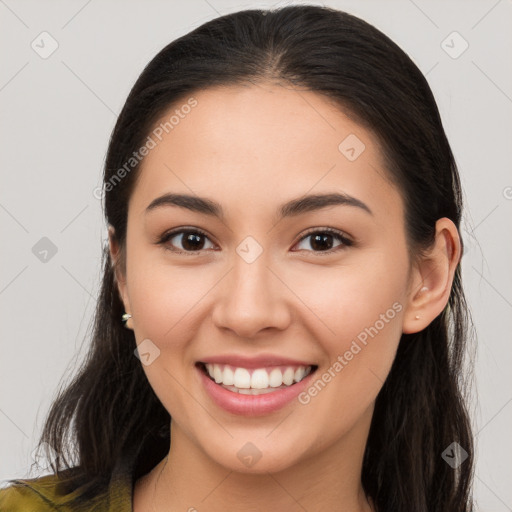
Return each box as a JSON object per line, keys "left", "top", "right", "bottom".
{"left": 196, "top": 366, "right": 316, "bottom": 416}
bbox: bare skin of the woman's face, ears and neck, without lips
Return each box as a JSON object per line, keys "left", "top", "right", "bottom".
{"left": 110, "top": 83, "right": 461, "bottom": 512}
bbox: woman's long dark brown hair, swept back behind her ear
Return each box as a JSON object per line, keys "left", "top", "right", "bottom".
{"left": 31, "top": 5, "right": 473, "bottom": 512}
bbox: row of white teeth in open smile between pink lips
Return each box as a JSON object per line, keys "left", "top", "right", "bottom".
{"left": 196, "top": 361, "right": 318, "bottom": 396}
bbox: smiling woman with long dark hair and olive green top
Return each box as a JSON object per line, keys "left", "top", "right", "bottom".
{"left": 0, "top": 6, "right": 473, "bottom": 512}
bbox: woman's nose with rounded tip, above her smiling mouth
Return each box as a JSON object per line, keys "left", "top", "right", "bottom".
{"left": 213, "top": 255, "right": 291, "bottom": 339}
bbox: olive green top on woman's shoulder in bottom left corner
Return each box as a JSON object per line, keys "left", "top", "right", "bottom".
{"left": 0, "top": 450, "right": 134, "bottom": 512}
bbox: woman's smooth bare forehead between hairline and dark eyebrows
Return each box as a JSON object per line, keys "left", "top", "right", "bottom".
{"left": 130, "top": 84, "right": 402, "bottom": 222}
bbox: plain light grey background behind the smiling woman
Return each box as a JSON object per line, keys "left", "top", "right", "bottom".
{"left": 0, "top": 0, "right": 512, "bottom": 512}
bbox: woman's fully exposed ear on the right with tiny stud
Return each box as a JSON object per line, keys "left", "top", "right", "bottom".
{"left": 402, "top": 217, "right": 462, "bottom": 334}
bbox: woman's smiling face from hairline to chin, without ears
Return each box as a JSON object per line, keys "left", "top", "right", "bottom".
{"left": 113, "top": 84, "right": 416, "bottom": 472}
